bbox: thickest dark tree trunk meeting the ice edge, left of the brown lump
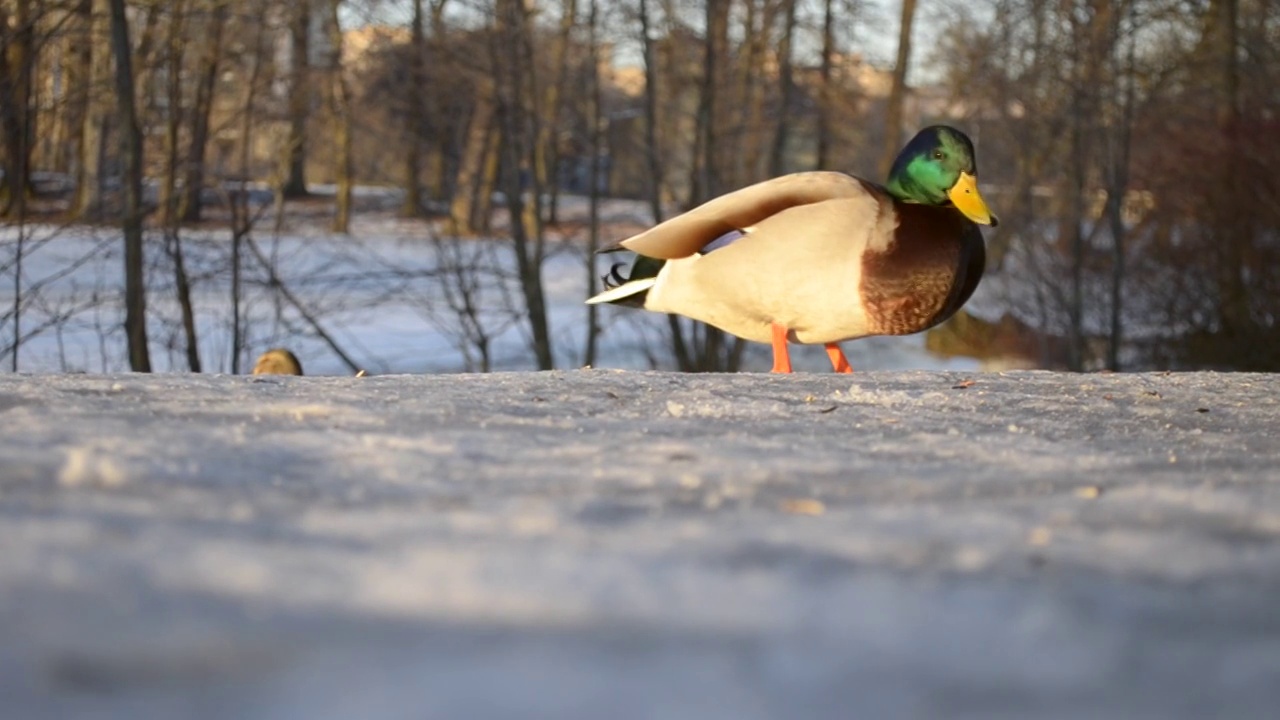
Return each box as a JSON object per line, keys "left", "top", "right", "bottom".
{"left": 109, "top": 0, "right": 151, "bottom": 373}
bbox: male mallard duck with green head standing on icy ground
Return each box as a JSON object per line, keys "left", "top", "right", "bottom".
{"left": 588, "top": 126, "right": 997, "bottom": 373}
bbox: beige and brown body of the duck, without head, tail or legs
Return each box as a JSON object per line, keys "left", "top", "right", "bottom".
{"left": 622, "top": 173, "right": 986, "bottom": 345}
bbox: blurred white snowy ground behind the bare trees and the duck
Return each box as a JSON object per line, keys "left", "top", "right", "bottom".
{"left": 0, "top": 196, "right": 977, "bottom": 375}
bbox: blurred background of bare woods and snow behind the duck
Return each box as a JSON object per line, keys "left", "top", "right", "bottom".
{"left": 0, "top": 0, "right": 1280, "bottom": 374}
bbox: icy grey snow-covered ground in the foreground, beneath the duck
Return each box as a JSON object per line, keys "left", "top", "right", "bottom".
{"left": 0, "top": 370, "right": 1280, "bottom": 720}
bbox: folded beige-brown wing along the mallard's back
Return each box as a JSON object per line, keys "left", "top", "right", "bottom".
{"left": 602, "top": 172, "right": 883, "bottom": 260}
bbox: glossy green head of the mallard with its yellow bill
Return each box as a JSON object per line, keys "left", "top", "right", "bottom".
{"left": 886, "top": 126, "right": 1000, "bottom": 225}
